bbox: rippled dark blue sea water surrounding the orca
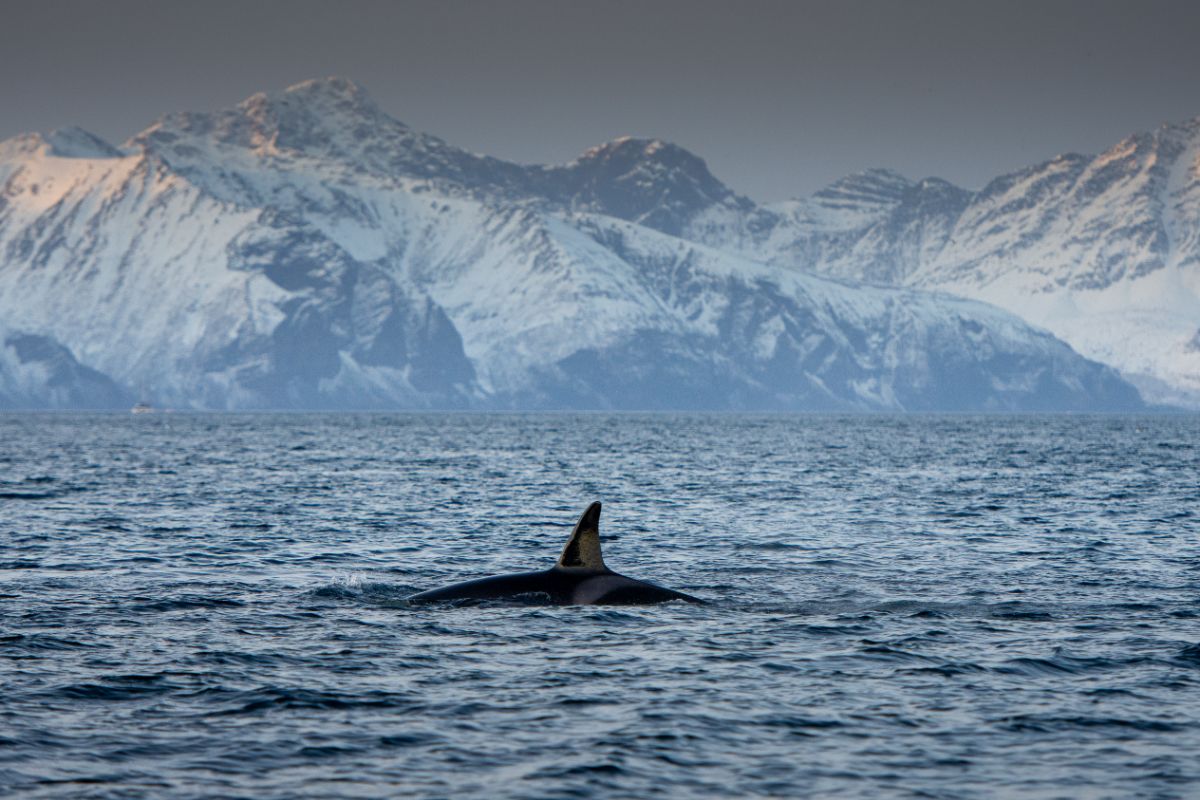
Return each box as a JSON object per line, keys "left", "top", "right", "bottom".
{"left": 0, "top": 414, "right": 1200, "bottom": 799}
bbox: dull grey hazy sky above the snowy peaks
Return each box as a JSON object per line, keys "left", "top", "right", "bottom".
{"left": 0, "top": 0, "right": 1200, "bottom": 200}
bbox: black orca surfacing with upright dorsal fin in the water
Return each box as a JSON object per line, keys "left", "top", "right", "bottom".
{"left": 408, "top": 503, "right": 704, "bottom": 606}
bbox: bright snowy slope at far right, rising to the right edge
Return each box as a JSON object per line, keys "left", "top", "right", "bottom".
{"left": 908, "top": 121, "right": 1200, "bottom": 407}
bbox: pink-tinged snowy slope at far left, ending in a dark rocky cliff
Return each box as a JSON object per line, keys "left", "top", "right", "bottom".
{"left": 0, "top": 121, "right": 475, "bottom": 408}
